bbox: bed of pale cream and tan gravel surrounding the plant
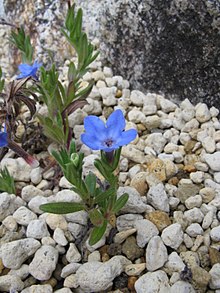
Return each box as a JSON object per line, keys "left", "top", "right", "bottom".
{"left": 0, "top": 56, "right": 220, "bottom": 293}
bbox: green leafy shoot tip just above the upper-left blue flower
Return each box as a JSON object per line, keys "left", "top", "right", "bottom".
{"left": 10, "top": 27, "right": 34, "bottom": 63}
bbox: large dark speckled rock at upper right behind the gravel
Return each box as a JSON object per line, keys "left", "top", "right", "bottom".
{"left": 98, "top": 0, "right": 220, "bottom": 105}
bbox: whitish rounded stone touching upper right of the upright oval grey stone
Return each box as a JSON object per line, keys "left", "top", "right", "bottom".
{"left": 161, "top": 223, "right": 183, "bottom": 249}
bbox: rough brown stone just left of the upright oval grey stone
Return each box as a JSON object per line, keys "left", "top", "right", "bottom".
{"left": 122, "top": 236, "right": 144, "bottom": 261}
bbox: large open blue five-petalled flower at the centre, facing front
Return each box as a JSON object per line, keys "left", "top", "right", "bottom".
{"left": 81, "top": 110, "right": 137, "bottom": 152}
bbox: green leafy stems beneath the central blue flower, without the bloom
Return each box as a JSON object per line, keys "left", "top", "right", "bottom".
{"left": 40, "top": 141, "right": 128, "bottom": 245}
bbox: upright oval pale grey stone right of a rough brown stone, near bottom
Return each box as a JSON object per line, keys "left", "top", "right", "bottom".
{"left": 146, "top": 236, "right": 168, "bottom": 271}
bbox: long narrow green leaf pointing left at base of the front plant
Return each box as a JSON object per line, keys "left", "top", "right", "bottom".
{"left": 40, "top": 202, "right": 85, "bottom": 214}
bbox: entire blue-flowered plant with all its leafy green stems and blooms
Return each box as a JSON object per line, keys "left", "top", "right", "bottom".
{"left": 0, "top": 1, "right": 137, "bottom": 245}
